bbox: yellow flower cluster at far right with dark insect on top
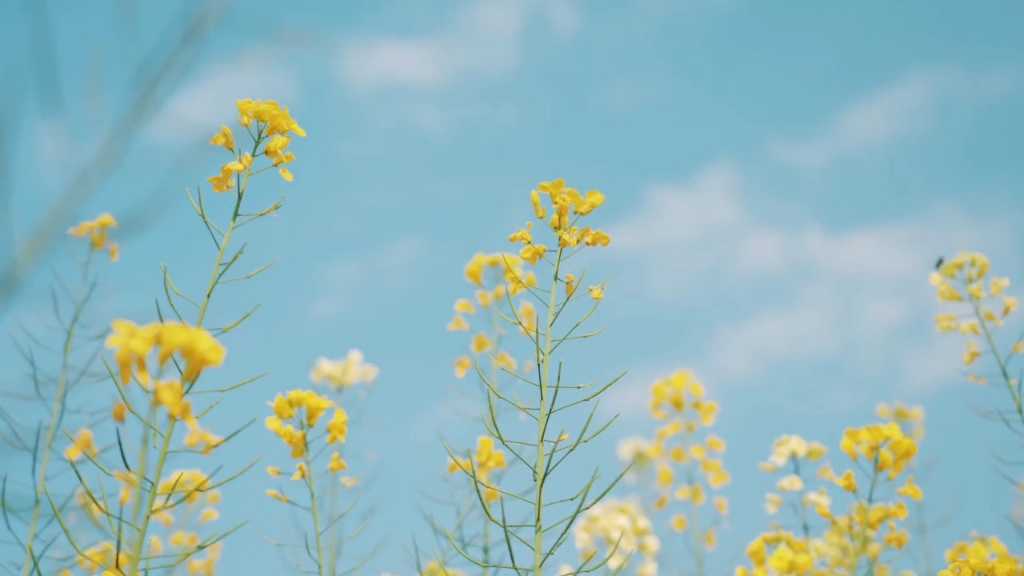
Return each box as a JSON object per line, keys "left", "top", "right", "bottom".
{"left": 929, "top": 252, "right": 1024, "bottom": 377}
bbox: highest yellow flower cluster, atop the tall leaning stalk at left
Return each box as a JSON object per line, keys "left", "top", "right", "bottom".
{"left": 207, "top": 99, "right": 306, "bottom": 193}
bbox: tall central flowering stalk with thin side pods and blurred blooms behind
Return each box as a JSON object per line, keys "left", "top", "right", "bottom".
{"left": 445, "top": 179, "right": 625, "bottom": 576}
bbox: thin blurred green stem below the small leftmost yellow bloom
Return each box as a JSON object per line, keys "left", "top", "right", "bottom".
{"left": 22, "top": 251, "right": 95, "bottom": 576}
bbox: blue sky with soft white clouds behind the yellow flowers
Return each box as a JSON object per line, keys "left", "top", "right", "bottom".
{"left": 6, "top": 0, "right": 1024, "bottom": 574}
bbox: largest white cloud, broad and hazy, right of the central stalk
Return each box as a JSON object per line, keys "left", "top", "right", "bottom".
{"left": 609, "top": 164, "right": 1013, "bottom": 399}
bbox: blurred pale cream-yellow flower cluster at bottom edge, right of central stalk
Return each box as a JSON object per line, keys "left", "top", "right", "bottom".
{"left": 573, "top": 498, "right": 662, "bottom": 576}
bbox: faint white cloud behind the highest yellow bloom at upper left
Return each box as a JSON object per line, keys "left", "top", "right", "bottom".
{"left": 150, "top": 50, "right": 299, "bottom": 141}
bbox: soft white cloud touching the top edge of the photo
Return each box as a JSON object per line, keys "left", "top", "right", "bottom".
{"left": 337, "top": 0, "right": 580, "bottom": 90}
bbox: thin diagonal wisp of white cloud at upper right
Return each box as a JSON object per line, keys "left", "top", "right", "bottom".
{"left": 770, "top": 70, "right": 1018, "bottom": 169}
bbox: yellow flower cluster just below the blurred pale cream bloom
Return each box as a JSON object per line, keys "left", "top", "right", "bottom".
{"left": 266, "top": 389, "right": 348, "bottom": 502}
